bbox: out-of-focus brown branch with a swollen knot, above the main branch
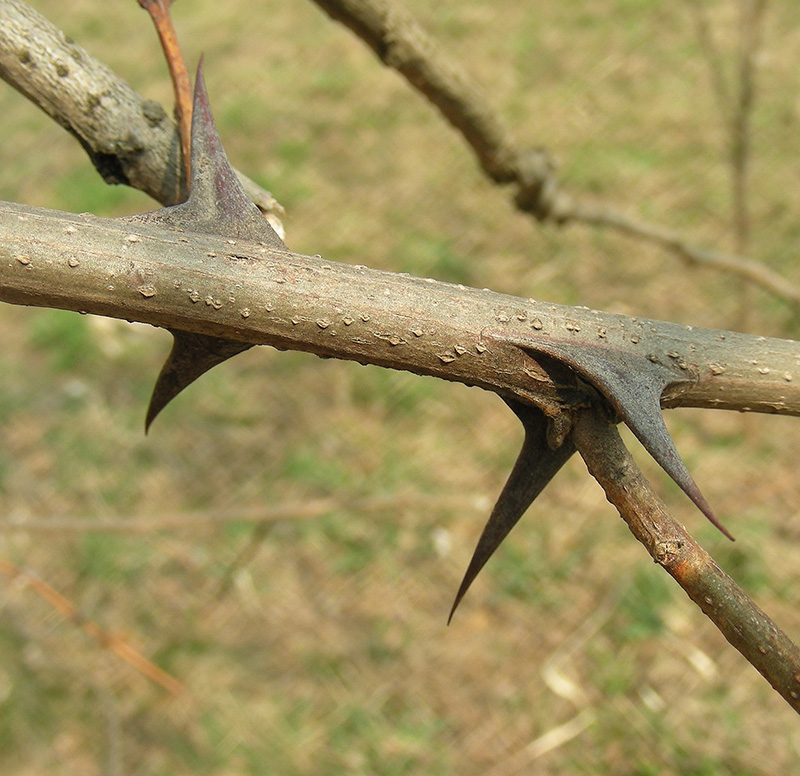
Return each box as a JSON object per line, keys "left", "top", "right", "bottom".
{"left": 314, "top": 0, "right": 800, "bottom": 304}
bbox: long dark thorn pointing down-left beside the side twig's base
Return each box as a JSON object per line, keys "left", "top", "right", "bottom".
{"left": 447, "top": 400, "right": 575, "bottom": 625}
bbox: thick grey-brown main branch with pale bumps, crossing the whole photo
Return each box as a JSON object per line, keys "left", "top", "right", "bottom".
{"left": 0, "top": 203, "right": 800, "bottom": 415}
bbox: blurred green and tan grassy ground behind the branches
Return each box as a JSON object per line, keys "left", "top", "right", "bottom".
{"left": 0, "top": 0, "right": 800, "bottom": 776}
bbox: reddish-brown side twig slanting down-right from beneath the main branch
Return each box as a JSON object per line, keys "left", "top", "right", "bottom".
{"left": 573, "top": 410, "right": 800, "bottom": 712}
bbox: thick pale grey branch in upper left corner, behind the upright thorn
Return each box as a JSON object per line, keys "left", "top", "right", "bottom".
{"left": 0, "top": 0, "right": 283, "bottom": 223}
